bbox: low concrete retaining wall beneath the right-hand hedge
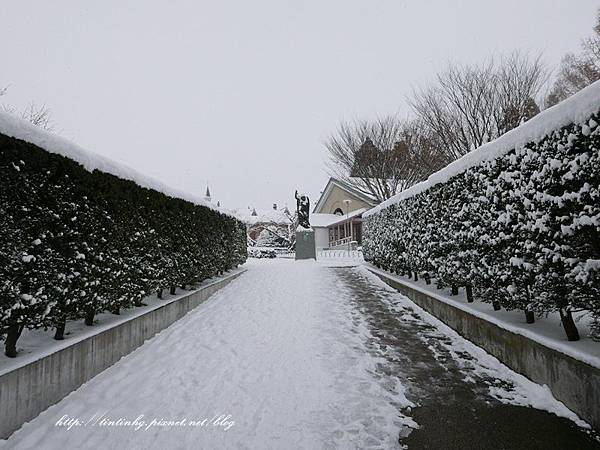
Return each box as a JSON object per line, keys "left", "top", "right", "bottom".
{"left": 369, "top": 269, "right": 600, "bottom": 430}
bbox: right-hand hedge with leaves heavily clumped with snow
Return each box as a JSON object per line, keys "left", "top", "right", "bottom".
{"left": 363, "top": 89, "right": 600, "bottom": 340}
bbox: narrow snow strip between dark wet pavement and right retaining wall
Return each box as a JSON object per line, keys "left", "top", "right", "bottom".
{"left": 361, "top": 266, "right": 590, "bottom": 428}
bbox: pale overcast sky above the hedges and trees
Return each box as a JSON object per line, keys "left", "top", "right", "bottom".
{"left": 0, "top": 0, "right": 600, "bottom": 208}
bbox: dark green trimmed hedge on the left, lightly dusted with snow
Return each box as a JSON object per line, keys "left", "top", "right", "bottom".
{"left": 0, "top": 133, "right": 246, "bottom": 356}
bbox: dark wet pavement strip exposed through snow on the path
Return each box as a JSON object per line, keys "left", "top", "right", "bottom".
{"left": 338, "top": 268, "right": 600, "bottom": 450}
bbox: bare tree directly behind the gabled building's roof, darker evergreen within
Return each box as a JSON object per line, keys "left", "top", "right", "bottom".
{"left": 325, "top": 116, "right": 439, "bottom": 201}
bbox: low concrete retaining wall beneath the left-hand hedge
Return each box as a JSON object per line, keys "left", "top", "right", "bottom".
{"left": 0, "top": 270, "right": 244, "bottom": 439}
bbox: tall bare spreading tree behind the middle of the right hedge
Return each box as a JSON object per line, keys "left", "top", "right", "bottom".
{"left": 408, "top": 52, "right": 547, "bottom": 161}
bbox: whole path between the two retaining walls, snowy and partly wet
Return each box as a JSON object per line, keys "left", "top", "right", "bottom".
{"left": 0, "top": 260, "right": 597, "bottom": 449}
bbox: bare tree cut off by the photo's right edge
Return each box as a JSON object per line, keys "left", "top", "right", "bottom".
{"left": 546, "top": 10, "right": 600, "bottom": 106}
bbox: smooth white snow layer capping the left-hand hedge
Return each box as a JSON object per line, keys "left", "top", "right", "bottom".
{"left": 0, "top": 111, "right": 235, "bottom": 217}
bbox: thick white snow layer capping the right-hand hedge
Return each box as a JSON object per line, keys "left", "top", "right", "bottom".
{"left": 363, "top": 81, "right": 600, "bottom": 217}
